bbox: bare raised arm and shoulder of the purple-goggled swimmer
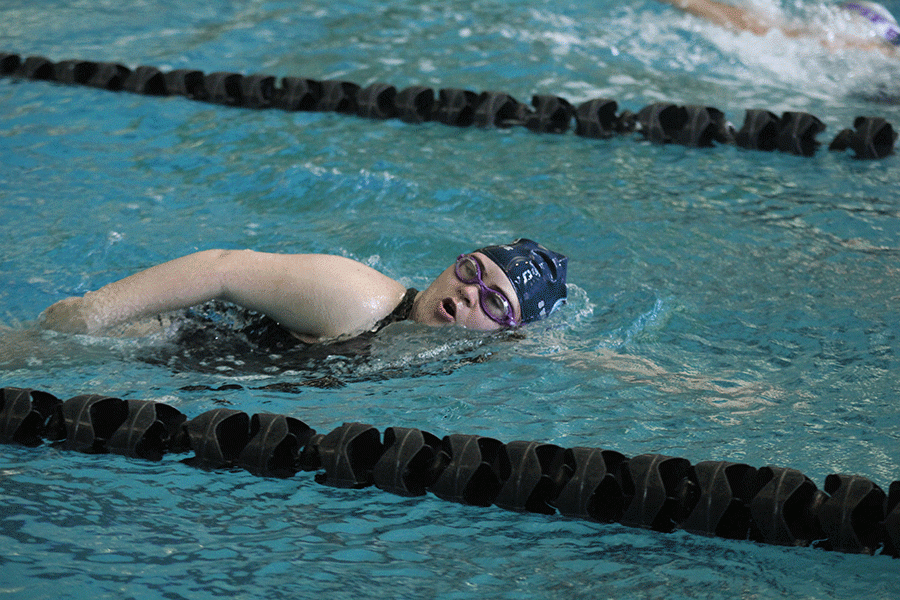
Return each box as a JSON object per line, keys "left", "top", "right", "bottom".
{"left": 42, "top": 250, "right": 406, "bottom": 341}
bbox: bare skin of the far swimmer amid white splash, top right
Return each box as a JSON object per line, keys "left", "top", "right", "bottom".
{"left": 660, "top": 0, "right": 896, "bottom": 56}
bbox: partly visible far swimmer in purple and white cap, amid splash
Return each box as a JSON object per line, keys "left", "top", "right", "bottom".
{"left": 660, "top": 0, "right": 900, "bottom": 55}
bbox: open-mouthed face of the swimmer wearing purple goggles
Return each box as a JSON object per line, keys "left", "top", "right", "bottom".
{"left": 412, "top": 252, "right": 522, "bottom": 331}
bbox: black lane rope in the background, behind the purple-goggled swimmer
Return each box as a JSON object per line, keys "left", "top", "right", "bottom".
{"left": 0, "top": 52, "right": 897, "bottom": 159}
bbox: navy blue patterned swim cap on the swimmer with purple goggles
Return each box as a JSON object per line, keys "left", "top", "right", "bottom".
{"left": 476, "top": 238, "right": 569, "bottom": 323}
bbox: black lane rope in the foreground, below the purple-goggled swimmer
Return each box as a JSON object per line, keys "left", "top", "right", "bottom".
{"left": 0, "top": 387, "right": 900, "bottom": 558}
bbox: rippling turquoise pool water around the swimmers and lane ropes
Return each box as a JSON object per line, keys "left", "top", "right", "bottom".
{"left": 0, "top": 0, "right": 900, "bottom": 599}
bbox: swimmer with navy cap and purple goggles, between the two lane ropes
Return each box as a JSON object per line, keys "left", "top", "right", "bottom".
{"left": 41, "top": 239, "right": 568, "bottom": 343}
